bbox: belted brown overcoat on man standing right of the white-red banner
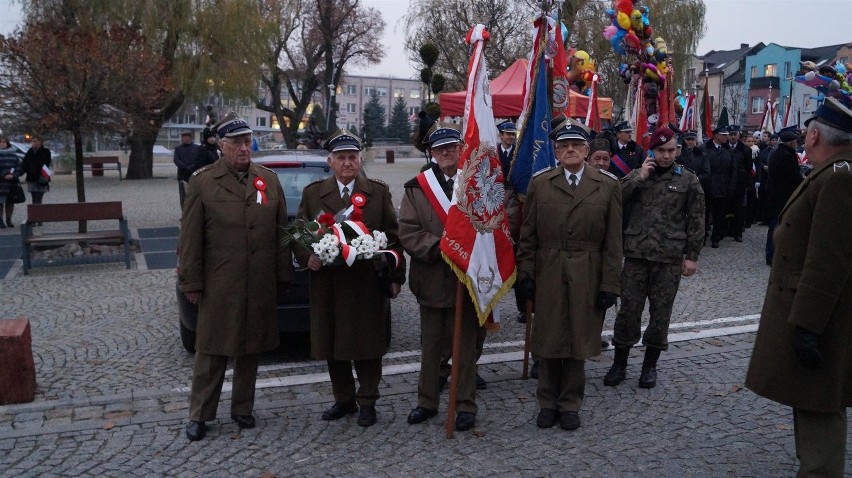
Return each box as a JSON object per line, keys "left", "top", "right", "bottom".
{"left": 518, "top": 166, "right": 622, "bottom": 360}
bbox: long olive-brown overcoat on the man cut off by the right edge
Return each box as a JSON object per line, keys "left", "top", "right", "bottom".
{"left": 746, "top": 150, "right": 852, "bottom": 412}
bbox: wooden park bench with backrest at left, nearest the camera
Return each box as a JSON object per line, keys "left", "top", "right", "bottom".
{"left": 21, "top": 201, "right": 130, "bottom": 275}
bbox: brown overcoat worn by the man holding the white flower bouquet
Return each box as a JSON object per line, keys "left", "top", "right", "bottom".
{"left": 296, "top": 176, "right": 405, "bottom": 360}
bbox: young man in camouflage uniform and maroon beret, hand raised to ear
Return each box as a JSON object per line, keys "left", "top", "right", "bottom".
{"left": 604, "top": 127, "right": 704, "bottom": 388}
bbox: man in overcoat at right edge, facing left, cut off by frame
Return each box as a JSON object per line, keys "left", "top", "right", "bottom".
{"left": 746, "top": 98, "right": 852, "bottom": 478}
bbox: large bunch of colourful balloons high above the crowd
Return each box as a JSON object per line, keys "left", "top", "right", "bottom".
{"left": 603, "top": 0, "right": 669, "bottom": 88}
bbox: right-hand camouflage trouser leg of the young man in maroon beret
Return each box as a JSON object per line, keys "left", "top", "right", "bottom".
{"left": 642, "top": 262, "right": 681, "bottom": 350}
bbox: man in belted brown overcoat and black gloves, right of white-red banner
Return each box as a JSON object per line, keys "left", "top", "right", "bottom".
{"left": 518, "top": 115, "right": 621, "bottom": 430}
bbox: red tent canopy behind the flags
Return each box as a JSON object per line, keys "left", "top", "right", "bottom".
{"left": 438, "top": 58, "right": 612, "bottom": 120}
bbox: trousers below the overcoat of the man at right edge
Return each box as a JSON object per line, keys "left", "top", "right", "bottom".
{"left": 793, "top": 408, "right": 846, "bottom": 478}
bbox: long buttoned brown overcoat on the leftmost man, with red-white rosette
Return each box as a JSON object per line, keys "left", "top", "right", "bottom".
{"left": 179, "top": 160, "right": 293, "bottom": 356}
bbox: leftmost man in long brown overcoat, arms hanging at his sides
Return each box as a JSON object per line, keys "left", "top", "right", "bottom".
{"left": 179, "top": 117, "right": 293, "bottom": 441}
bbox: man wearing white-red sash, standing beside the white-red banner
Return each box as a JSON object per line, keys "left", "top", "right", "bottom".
{"left": 399, "top": 123, "right": 485, "bottom": 431}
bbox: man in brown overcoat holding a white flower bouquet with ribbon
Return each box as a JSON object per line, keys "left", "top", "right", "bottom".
{"left": 296, "top": 130, "right": 405, "bottom": 427}
